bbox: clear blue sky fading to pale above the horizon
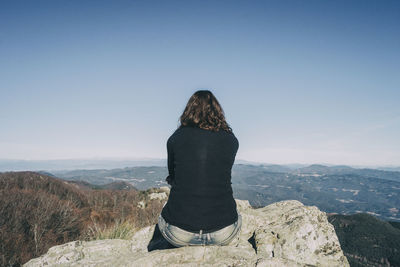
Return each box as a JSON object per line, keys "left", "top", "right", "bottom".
{"left": 0, "top": 0, "right": 400, "bottom": 166}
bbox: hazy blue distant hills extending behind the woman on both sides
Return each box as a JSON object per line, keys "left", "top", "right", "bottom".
{"left": 53, "top": 164, "right": 400, "bottom": 221}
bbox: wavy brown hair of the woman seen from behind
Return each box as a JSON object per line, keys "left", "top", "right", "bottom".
{"left": 180, "top": 90, "right": 232, "bottom": 133}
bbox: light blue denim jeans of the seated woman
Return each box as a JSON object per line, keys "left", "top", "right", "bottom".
{"left": 158, "top": 214, "right": 242, "bottom": 247}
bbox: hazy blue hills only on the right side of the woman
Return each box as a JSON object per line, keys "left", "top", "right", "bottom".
{"left": 232, "top": 165, "right": 400, "bottom": 221}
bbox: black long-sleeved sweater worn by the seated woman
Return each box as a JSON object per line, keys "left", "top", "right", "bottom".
{"left": 161, "top": 127, "right": 239, "bottom": 231}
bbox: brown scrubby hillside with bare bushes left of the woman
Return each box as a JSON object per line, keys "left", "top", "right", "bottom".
{"left": 0, "top": 172, "right": 163, "bottom": 266}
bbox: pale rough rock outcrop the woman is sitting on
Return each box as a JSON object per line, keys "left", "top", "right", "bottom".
{"left": 24, "top": 200, "right": 349, "bottom": 267}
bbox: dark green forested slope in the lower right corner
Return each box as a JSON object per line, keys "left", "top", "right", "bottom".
{"left": 328, "top": 214, "right": 400, "bottom": 267}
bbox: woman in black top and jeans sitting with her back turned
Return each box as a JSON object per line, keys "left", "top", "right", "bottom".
{"left": 158, "top": 90, "right": 241, "bottom": 247}
